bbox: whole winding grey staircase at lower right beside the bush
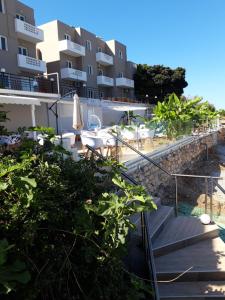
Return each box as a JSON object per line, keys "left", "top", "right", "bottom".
{"left": 147, "top": 200, "right": 225, "bottom": 300}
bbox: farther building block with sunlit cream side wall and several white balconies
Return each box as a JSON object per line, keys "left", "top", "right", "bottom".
{"left": 38, "top": 20, "right": 136, "bottom": 99}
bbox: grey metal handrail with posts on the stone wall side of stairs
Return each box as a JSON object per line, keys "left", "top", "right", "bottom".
{"left": 109, "top": 132, "right": 222, "bottom": 220}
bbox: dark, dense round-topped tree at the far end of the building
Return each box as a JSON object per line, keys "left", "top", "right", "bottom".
{"left": 134, "top": 64, "right": 188, "bottom": 104}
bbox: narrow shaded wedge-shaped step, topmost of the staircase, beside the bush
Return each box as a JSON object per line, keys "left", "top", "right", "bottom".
{"left": 146, "top": 205, "right": 174, "bottom": 242}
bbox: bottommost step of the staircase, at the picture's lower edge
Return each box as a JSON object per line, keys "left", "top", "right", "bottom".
{"left": 159, "top": 281, "right": 225, "bottom": 300}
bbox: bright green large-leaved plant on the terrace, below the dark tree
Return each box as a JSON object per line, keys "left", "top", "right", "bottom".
{"left": 153, "top": 93, "right": 217, "bottom": 138}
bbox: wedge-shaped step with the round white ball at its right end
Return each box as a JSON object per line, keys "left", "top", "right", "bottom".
{"left": 153, "top": 216, "right": 219, "bottom": 256}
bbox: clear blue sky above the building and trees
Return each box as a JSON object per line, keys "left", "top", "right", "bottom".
{"left": 21, "top": 0, "right": 225, "bottom": 108}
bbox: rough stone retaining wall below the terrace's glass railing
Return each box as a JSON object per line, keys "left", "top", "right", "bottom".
{"left": 126, "top": 132, "right": 218, "bottom": 204}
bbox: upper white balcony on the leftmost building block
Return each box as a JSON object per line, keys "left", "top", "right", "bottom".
{"left": 15, "top": 19, "right": 44, "bottom": 43}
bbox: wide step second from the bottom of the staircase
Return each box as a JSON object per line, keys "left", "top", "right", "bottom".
{"left": 155, "top": 237, "right": 225, "bottom": 281}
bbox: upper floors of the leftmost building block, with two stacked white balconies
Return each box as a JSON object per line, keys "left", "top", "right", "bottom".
{"left": 0, "top": 0, "right": 46, "bottom": 76}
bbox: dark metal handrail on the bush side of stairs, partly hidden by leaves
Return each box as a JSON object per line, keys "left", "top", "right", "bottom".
{"left": 85, "top": 145, "right": 159, "bottom": 300}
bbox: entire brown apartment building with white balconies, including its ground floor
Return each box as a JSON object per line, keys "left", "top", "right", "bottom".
{"left": 0, "top": 0, "right": 142, "bottom": 132}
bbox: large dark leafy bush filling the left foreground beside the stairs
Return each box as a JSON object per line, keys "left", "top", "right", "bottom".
{"left": 0, "top": 132, "right": 155, "bottom": 300}
